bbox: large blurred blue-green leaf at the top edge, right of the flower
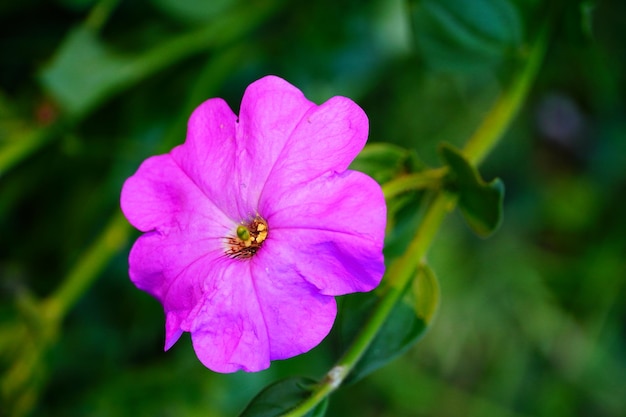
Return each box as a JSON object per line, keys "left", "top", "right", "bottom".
{"left": 410, "top": 0, "right": 522, "bottom": 71}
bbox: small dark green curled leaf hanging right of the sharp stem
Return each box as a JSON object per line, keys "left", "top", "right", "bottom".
{"left": 439, "top": 143, "right": 504, "bottom": 237}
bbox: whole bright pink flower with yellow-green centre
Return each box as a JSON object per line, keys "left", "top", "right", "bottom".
{"left": 121, "top": 76, "right": 386, "bottom": 372}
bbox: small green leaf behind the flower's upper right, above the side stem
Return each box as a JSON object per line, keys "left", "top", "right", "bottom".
{"left": 350, "top": 143, "right": 423, "bottom": 184}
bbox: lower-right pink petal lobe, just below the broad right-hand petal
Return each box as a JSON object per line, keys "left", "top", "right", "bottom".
{"left": 251, "top": 250, "right": 337, "bottom": 360}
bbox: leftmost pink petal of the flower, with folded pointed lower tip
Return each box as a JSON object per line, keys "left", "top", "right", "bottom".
{"left": 121, "top": 155, "right": 235, "bottom": 349}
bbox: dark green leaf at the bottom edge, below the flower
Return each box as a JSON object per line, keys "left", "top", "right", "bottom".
{"left": 239, "top": 377, "right": 328, "bottom": 417}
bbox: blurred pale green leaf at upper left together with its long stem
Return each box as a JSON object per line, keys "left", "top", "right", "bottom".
{"left": 40, "top": 1, "right": 279, "bottom": 116}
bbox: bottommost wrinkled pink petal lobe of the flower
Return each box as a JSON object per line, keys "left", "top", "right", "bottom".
{"left": 183, "top": 258, "right": 270, "bottom": 372}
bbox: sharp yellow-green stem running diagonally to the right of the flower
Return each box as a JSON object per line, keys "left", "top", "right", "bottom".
{"left": 284, "top": 23, "right": 547, "bottom": 417}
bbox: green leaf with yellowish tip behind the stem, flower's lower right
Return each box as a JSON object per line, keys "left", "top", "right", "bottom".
{"left": 340, "top": 265, "right": 439, "bottom": 384}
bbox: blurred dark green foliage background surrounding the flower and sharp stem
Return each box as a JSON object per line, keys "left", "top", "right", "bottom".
{"left": 0, "top": 0, "right": 626, "bottom": 417}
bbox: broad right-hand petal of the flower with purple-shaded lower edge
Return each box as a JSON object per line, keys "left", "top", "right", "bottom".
{"left": 259, "top": 171, "right": 386, "bottom": 295}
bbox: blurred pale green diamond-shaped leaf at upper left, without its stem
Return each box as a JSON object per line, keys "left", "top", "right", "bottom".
{"left": 40, "top": 26, "right": 130, "bottom": 115}
